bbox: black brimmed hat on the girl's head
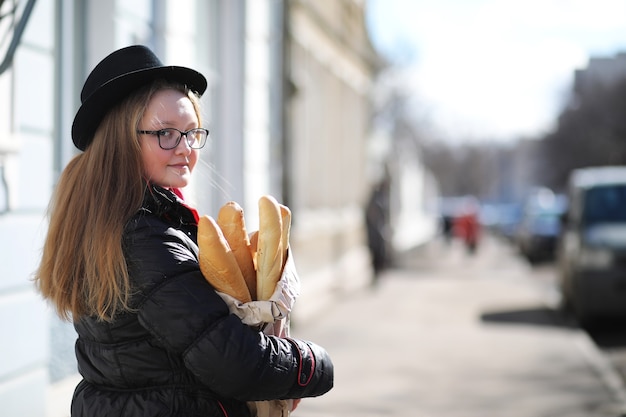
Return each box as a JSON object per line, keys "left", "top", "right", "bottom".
{"left": 72, "top": 45, "right": 207, "bottom": 151}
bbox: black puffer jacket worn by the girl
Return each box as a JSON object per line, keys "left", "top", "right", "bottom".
{"left": 72, "top": 187, "right": 333, "bottom": 417}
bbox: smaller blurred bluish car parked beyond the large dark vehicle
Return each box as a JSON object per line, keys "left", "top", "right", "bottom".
{"left": 515, "top": 188, "right": 567, "bottom": 264}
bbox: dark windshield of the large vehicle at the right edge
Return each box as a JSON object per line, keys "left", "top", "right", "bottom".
{"left": 583, "top": 184, "right": 626, "bottom": 224}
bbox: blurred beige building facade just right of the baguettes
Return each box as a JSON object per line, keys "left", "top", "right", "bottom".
{"left": 286, "top": 0, "right": 375, "bottom": 322}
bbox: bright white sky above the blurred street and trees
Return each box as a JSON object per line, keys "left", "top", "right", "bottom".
{"left": 367, "top": 0, "right": 626, "bottom": 141}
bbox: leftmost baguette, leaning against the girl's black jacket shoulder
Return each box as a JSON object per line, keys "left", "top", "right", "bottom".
{"left": 198, "top": 215, "right": 252, "bottom": 303}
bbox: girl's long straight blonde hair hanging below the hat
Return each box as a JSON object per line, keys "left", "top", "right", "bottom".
{"left": 34, "top": 81, "right": 200, "bottom": 321}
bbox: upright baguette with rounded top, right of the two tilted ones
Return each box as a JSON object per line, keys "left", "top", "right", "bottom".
{"left": 256, "top": 195, "right": 283, "bottom": 300}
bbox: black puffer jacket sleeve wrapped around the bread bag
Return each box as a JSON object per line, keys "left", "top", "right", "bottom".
{"left": 127, "top": 218, "right": 333, "bottom": 401}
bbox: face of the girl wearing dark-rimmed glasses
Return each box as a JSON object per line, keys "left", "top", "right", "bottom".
{"left": 139, "top": 89, "right": 199, "bottom": 188}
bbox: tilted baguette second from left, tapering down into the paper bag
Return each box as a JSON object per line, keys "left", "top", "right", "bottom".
{"left": 217, "top": 201, "right": 257, "bottom": 300}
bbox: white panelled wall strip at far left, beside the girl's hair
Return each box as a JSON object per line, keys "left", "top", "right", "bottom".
{"left": 0, "top": 2, "right": 55, "bottom": 417}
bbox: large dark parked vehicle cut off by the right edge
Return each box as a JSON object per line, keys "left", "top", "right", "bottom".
{"left": 558, "top": 167, "right": 626, "bottom": 325}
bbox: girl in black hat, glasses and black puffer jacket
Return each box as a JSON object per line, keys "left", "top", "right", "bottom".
{"left": 35, "top": 45, "right": 334, "bottom": 417}
